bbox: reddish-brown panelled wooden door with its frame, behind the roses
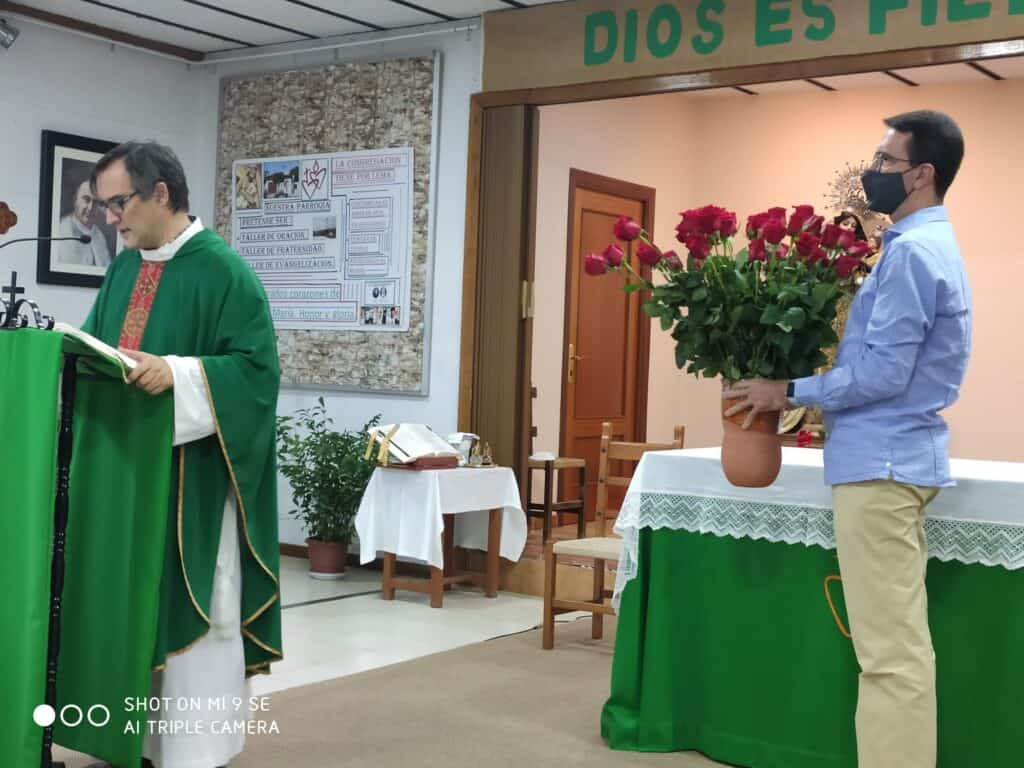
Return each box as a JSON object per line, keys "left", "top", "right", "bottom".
{"left": 560, "top": 170, "right": 654, "bottom": 519}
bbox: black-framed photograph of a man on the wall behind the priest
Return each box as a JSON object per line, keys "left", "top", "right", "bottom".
{"left": 36, "top": 131, "right": 121, "bottom": 288}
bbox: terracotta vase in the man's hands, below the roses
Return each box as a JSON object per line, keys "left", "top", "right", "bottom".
{"left": 722, "top": 382, "right": 782, "bottom": 488}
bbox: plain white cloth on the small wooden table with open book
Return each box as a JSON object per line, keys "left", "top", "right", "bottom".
{"left": 355, "top": 467, "right": 526, "bottom": 568}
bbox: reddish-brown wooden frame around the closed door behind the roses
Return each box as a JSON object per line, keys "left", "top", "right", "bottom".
{"left": 558, "top": 168, "right": 655, "bottom": 456}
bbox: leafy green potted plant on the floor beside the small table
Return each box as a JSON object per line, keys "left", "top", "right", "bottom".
{"left": 278, "top": 397, "right": 380, "bottom": 579}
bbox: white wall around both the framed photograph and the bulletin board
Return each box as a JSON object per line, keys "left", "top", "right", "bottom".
{"left": 0, "top": 18, "right": 480, "bottom": 544}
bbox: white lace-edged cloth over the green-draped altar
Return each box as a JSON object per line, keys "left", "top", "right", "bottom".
{"left": 613, "top": 447, "right": 1024, "bottom": 607}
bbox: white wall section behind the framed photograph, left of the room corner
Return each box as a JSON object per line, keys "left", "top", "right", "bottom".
{"left": 0, "top": 18, "right": 213, "bottom": 325}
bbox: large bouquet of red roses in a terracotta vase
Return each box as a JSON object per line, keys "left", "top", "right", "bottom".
{"left": 584, "top": 205, "right": 871, "bottom": 487}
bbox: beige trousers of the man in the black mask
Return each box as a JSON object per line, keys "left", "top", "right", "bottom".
{"left": 833, "top": 480, "right": 938, "bottom": 768}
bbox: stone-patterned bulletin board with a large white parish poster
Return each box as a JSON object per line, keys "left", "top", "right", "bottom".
{"left": 216, "top": 56, "right": 440, "bottom": 395}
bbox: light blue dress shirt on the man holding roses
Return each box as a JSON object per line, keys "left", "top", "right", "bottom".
{"left": 791, "top": 206, "right": 971, "bottom": 487}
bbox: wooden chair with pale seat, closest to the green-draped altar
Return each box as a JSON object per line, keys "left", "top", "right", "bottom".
{"left": 542, "top": 422, "right": 685, "bottom": 649}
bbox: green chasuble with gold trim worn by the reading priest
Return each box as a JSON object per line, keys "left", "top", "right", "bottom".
{"left": 83, "top": 229, "right": 282, "bottom": 674}
